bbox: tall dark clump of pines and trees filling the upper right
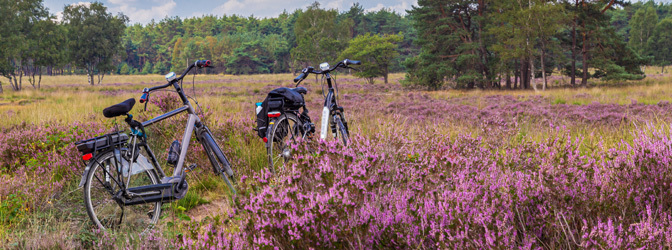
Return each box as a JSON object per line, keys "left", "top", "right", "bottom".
{"left": 405, "top": 0, "right": 672, "bottom": 90}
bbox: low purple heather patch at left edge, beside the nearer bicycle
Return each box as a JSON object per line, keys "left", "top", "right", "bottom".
{"left": 0, "top": 123, "right": 106, "bottom": 209}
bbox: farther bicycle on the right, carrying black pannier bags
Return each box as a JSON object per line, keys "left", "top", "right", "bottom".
{"left": 263, "top": 59, "right": 362, "bottom": 172}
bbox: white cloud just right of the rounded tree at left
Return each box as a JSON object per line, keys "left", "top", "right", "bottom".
{"left": 108, "top": 0, "right": 177, "bottom": 23}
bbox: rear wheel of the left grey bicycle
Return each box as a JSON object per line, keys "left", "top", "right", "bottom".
{"left": 84, "top": 151, "right": 161, "bottom": 233}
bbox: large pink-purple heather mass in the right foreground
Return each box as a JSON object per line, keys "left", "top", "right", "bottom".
{"left": 182, "top": 124, "right": 672, "bottom": 249}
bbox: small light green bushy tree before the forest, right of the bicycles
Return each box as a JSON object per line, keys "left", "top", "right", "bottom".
{"left": 341, "top": 33, "right": 403, "bottom": 83}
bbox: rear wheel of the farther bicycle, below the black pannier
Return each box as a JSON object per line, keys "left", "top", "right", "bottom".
{"left": 266, "top": 113, "right": 306, "bottom": 173}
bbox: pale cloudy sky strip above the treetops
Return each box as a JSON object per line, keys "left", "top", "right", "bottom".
{"left": 44, "top": 0, "right": 418, "bottom": 24}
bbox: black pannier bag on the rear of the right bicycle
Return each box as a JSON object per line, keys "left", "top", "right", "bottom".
{"left": 257, "top": 87, "right": 306, "bottom": 138}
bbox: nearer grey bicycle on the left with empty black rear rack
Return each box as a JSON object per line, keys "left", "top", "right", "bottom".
{"left": 75, "top": 60, "right": 236, "bottom": 230}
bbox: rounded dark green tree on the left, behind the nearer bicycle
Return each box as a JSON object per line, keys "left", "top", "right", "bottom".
{"left": 63, "top": 2, "right": 128, "bottom": 85}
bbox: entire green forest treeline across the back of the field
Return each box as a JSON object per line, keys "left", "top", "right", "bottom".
{"left": 0, "top": 0, "right": 672, "bottom": 91}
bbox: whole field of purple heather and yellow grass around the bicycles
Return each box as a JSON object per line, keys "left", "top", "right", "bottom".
{"left": 0, "top": 75, "right": 672, "bottom": 249}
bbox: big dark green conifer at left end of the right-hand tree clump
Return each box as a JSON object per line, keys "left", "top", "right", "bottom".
{"left": 405, "top": 0, "right": 493, "bottom": 89}
